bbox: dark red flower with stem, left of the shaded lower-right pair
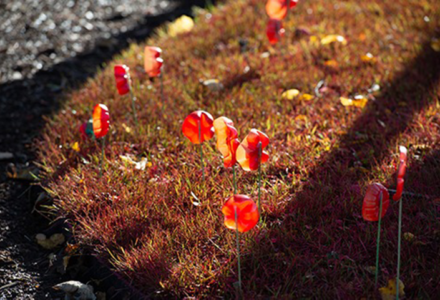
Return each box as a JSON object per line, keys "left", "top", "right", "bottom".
{"left": 362, "top": 183, "right": 390, "bottom": 285}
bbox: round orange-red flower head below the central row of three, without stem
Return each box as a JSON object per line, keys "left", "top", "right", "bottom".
{"left": 222, "top": 195, "right": 260, "bottom": 232}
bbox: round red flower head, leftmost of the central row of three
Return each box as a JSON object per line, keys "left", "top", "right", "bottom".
{"left": 182, "top": 110, "right": 214, "bottom": 144}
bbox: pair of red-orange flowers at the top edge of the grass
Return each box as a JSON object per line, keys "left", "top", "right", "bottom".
{"left": 266, "top": 0, "right": 298, "bottom": 45}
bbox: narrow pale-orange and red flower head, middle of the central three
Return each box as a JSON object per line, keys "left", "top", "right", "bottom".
{"left": 214, "top": 117, "right": 240, "bottom": 168}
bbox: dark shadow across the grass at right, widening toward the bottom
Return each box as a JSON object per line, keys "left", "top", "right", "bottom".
{"left": 245, "top": 42, "right": 440, "bottom": 299}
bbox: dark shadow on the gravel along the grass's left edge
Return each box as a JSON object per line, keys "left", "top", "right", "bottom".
{"left": 0, "top": 0, "right": 215, "bottom": 299}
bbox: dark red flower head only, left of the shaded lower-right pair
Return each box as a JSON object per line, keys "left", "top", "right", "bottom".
{"left": 362, "top": 183, "right": 390, "bottom": 221}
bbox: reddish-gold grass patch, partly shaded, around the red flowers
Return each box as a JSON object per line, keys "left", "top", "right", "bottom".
{"left": 37, "top": 0, "right": 440, "bottom": 299}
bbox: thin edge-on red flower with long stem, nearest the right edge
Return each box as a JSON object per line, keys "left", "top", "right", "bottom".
{"left": 393, "top": 146, "right": 408, "bottom": 300}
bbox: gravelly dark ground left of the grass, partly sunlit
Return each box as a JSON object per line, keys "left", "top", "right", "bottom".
{"left": 0, "top": 0, "right": 213, "bottom": 300}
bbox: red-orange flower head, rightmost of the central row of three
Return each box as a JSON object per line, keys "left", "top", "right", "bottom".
{"left": 236, "top": 129, "right": 269, "bottom": 171}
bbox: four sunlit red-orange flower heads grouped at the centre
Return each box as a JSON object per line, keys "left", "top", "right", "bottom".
{"left": 182, "top": 110, "right": 269, "bottom": 232}
